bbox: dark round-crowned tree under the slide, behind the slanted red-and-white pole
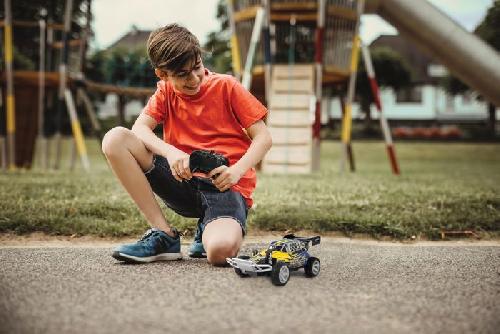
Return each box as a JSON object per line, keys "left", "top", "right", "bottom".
{"left": 356, "top": 48, "right": 412, "bottom": 130}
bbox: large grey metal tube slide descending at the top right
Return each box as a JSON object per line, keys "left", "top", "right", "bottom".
{"left": 365, "top": 0, "right": 500, "bottom": 107}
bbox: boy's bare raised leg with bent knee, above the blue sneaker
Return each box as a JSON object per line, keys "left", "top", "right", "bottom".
{"left": 102, "top": 127, "right": 175, "bottom": 237}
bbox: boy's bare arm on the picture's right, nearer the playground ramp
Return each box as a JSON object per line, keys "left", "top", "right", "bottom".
{"left": 208, "top": 120, "right": 272, "bottom": 191}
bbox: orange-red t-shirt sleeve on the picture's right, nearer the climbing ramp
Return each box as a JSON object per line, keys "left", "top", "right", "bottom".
{"left": 230, "top": 80, "right": 267, "bottom": 129}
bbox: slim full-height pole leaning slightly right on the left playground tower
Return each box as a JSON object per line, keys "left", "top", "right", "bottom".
{"left": 54, "top": 0, "right": 73, "bottom": 169}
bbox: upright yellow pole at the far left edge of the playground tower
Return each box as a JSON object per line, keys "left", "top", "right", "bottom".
{"left": 4, "top": 0, "right": 16, "bottom": 170}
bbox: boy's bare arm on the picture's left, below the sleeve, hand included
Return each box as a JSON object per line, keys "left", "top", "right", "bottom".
{"left": 132, "top": 113, "right": 192, "bottom": 181}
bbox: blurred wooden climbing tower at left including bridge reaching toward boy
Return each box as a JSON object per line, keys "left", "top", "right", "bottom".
{"left": 0, "top": 0, "right": 158, "bottom": 170}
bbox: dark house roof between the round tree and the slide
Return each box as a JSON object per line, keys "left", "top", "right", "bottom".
{"left": 370, "top": 35, "right": 434, "bottom": 83}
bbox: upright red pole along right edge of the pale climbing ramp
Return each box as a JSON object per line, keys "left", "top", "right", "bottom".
{"left": 312, "top": 0, "right": 326, "bottom": 171}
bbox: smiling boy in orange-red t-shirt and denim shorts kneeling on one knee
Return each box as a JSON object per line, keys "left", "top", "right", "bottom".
{"left": 102, "top": 24, "right": 272, "bottom": 265}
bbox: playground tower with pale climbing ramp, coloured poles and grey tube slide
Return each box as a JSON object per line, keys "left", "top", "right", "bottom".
{"left": 228, "top": 0, "right": 500, "bottom": 174}
